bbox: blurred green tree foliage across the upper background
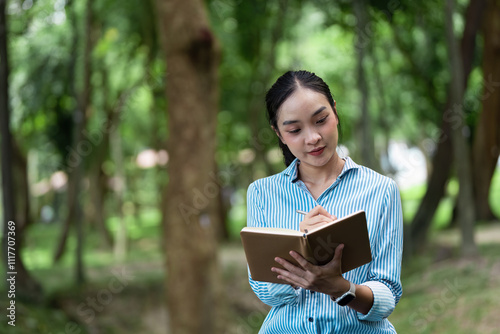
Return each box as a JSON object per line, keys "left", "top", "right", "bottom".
{"left": 4, "top": 0, "right": 492, "bottom": 232}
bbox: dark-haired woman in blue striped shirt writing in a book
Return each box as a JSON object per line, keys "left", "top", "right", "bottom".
{"left": 247, "top": 71, "right": 403, "bottom": 333}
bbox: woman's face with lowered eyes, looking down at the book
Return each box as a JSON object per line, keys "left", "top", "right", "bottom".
{"left": 275, "top": 87, "right": 338, "bottom": 167}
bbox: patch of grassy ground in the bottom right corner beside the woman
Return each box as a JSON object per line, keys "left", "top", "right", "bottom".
{"left": 389, "top": 243, "right": 500, "bottom": 334}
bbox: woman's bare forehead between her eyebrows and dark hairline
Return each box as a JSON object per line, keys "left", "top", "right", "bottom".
{"left": 278, "top": 87, "right": 331, "bottom": 123}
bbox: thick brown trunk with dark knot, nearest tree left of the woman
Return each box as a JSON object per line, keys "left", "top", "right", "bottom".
{"left": 157, "top": 0, "right": 223, "bottom": 334}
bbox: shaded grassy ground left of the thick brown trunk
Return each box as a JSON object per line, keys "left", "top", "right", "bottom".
{"left": 0, "top": 210, "right": 164, "bottom": 334}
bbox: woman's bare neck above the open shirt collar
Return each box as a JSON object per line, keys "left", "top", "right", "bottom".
{"left": 299, "top": 153, "right": 345, "bottom": 184}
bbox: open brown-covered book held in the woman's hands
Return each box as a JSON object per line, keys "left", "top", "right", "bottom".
{"left": 240, "top": 211, "right": 372, "bottom": 283}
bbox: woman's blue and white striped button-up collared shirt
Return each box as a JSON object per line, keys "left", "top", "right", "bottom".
{"left": 247, "top": 158, "right": 403, "bottom": 334}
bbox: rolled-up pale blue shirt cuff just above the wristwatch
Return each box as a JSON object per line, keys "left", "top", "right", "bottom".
{"left": 358, "top": 281, "right": 396, "bottom": 321}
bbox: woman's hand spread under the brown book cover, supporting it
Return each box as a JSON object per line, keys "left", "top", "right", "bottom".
{"left": 271, "top": 244, "right": 349, "bottom": 297}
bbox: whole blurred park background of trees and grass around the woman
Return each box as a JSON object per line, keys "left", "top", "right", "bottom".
{"left": 0, "top": 0, "right": 500, "bottom": 334}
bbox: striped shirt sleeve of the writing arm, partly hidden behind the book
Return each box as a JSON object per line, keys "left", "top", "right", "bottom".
{"left": 247, "top": 182, "right": 299, "bottom": 306}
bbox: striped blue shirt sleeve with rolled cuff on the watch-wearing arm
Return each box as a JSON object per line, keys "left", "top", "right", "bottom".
{"left": 358, "top": 180, "right": 403, "bottom": 321}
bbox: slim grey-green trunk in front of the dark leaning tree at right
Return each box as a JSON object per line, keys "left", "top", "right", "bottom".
{"left": 445, "top": 0, "right": 477, "bottom": 256}
